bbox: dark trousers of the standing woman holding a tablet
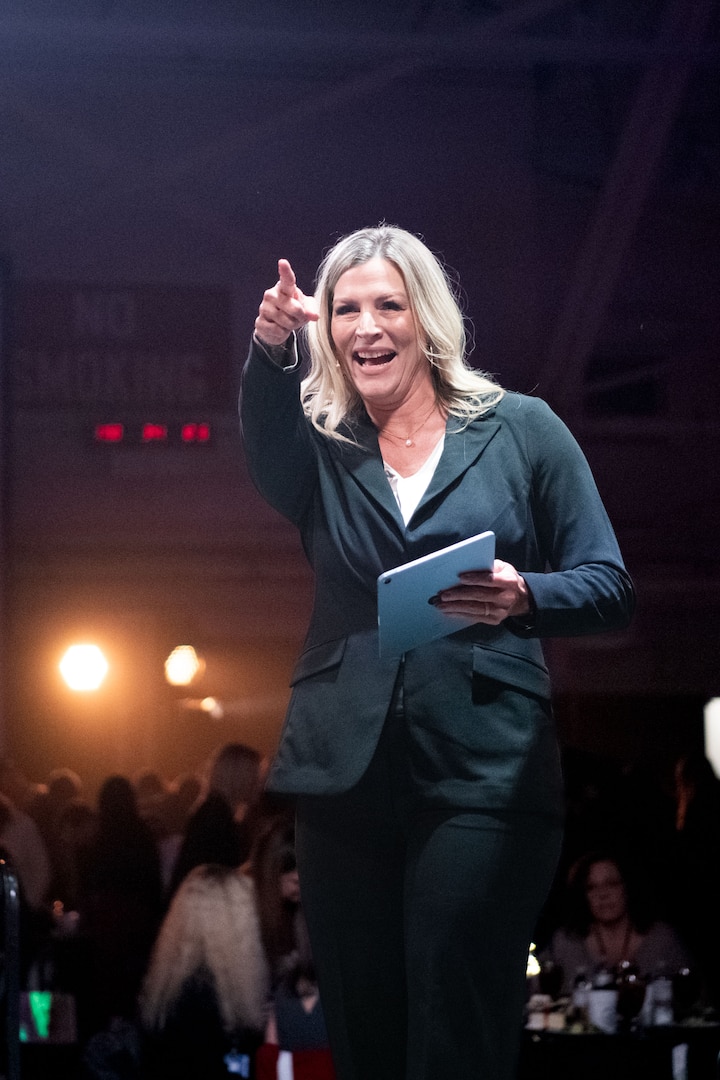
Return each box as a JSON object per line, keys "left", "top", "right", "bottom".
{"left": 296, "top": 669, "right": 561, "bottom": 1080}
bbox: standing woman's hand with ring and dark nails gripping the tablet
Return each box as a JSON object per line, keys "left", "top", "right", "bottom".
{"left": 432, "top": 558, "right": 530, "bottom": 626}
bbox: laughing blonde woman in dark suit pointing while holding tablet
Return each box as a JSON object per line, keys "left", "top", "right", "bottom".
{"left": 242, "top": 226, "right": 633, "bottom": 1080}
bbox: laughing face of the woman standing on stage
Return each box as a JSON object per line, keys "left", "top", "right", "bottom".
{"left": 330, "top": 257, "right": 432, "bottom": 408}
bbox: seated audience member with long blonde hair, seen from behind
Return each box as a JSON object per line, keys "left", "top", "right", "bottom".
{"left": 139, "top": 865, "right": 269, "bottom": 1080}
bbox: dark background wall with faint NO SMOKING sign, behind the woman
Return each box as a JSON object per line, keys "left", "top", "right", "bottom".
{"left": 0, "top": 0, "right": 720, "bottom": 794}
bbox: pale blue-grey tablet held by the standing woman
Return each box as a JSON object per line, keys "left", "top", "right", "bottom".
{"left": 378, "top": 532, "right": 495, "bottom": 658}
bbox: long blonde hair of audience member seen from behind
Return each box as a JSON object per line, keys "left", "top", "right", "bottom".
{"left": 139, "top": 864, "right": 270, "bottom": 1034}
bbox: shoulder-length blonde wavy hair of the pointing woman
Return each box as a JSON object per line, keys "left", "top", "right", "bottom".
{"left": 301, "top": 225, "right": 505, "bottom": 442}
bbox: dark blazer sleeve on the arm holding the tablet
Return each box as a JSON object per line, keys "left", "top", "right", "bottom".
{"left": 512, "top": 399, "right": 635, "bottom": 637}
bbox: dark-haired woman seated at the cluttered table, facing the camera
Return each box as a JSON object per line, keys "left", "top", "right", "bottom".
{"left": 539, "top": 851, "right": 691, "bottom": 994}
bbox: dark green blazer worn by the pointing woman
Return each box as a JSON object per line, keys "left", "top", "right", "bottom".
{"left": 241, "top": 345, "right": 634, "bottom": 813}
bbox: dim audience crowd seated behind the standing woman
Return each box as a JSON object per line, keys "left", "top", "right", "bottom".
{"left": 0, "top": 742, "right": 720, "bottom": 1080}
